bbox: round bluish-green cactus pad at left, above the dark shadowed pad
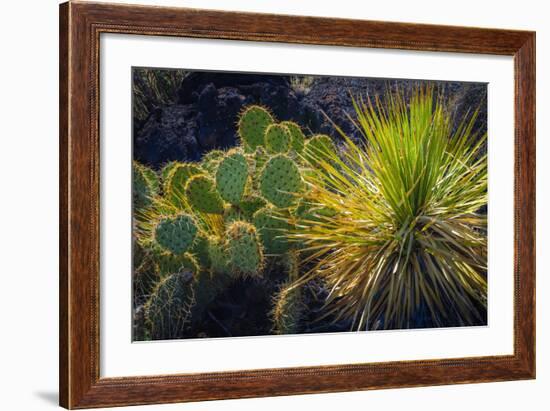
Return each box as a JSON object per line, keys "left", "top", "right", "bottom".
{"left": 155, "top": 214, "right": 197, "bottom": 254}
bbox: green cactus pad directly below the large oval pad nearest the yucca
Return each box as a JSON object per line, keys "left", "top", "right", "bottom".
{"left": 253, "top": 207, "right": 291, "bottom": 255}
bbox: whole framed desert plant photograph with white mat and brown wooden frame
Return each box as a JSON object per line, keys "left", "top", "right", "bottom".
{"left": 60, "top": 1, "right": 535, "bottom": 409}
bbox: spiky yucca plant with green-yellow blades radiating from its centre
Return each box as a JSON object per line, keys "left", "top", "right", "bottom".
{"left": 291, "top": 88, "right": 487, "bottom": 330}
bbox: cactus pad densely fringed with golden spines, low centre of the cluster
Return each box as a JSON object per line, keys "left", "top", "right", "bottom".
{"left": 226, "top": 221, "right": 264, "bottom": 277}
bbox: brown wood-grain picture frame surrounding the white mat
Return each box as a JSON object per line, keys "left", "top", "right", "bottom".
{"left": 60, "top": 2, "right": 535, "bottom": 408}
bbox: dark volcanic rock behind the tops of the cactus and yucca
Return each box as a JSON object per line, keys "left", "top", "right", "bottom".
{"left": 134, "top": 72, "right": 487, "bottom": 172}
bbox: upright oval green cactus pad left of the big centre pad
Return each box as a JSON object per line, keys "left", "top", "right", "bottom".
{"left": 216, "top": 152, "right": 248, "bottom": 205}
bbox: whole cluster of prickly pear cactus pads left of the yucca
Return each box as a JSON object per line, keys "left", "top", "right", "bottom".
{"left": 134, "top": 105, "right": 332, "bottom": 339}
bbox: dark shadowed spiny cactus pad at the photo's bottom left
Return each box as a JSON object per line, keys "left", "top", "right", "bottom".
{"left": 145, "top": 271, "right": 194, "bottom": 340}
